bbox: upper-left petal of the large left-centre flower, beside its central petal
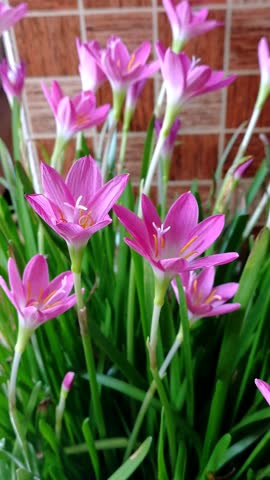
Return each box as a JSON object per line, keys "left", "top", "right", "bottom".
{"left": 41, "top": 163, "right": 76, "bottom": 205}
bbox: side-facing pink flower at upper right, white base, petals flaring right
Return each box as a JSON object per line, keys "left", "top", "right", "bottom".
{"left": 156, "top": 42, "right": 236, "bottom": 133}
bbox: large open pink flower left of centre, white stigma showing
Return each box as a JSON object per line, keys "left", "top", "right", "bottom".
{"left": 26, "top": 156, "right": 128, "bottom": 248}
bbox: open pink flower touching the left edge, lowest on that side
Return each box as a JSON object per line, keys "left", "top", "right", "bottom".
{"left": 0, "top": 255, "right": 76, "bottom": 329}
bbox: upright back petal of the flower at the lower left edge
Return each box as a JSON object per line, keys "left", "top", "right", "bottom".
{"left": 23, "top": 254, "right": 49, "bottom": 301}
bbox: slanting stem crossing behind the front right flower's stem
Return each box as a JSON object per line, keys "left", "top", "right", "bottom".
{"left": 125, "top": 330, "right": 183, "bottom": 460}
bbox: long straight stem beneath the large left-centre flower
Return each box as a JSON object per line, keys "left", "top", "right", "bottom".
{"left": 72, "top": 267, "right": 106, "bottom": 437}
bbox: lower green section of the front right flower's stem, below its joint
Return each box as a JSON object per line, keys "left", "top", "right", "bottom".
{"left": 151, "top": 368, "right": 176, "bottom": 470}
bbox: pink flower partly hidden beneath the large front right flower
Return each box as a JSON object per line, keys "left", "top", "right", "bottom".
{"left": 172, "top": 267, "right": 241, "bottom": 323}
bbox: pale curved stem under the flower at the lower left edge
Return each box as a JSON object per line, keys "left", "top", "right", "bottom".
{"left": 8, "top": 323, "right": 33, "bottom": 470}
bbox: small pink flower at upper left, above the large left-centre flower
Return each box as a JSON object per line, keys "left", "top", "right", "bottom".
{"left": 42, "top": 81, "right": 110, "bottom": 140}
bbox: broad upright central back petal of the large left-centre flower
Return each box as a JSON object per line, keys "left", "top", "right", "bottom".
{"left": 66, "top": 155, "right": 102, "bottom": 205}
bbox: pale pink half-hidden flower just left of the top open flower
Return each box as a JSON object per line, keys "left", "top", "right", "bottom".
{"left": 76, "top": 38, "right": 106, "bottom": 92}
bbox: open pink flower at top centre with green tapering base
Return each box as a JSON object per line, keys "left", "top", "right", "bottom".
{"left": 89, "top": 36, "right": 159, "bottom": 119}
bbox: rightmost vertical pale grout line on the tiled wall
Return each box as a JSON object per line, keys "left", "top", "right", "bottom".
{"left": 218, "top": 0, "right": 232, "bottom": 158}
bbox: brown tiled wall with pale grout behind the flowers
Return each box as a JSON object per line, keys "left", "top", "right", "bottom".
{"left": 6, "top": 0, "right": 270, "bottom": 201}
